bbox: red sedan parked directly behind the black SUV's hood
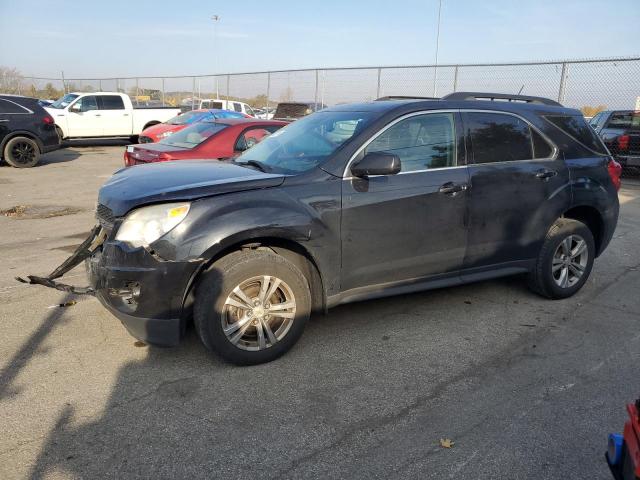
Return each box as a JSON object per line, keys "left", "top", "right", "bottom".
{"left": 124, "top": 118, "right": 287, "bottom": 167}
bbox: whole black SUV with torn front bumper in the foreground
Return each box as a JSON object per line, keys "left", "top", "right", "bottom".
{"left": 23, "top": 93, "right": 620, "bottom": 364}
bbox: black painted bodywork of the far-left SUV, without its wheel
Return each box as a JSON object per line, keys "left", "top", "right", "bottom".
{"left": 0, "top": 95, "right": 60, "bottom": 158}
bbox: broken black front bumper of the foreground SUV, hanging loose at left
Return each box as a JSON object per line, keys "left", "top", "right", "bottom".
{"left": 17, "top": 226, "right": 201, "bottom": 346}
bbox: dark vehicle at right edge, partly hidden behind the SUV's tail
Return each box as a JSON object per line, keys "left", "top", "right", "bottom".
{"left": 589, "top": 110, "right": 640, "bottom": 170}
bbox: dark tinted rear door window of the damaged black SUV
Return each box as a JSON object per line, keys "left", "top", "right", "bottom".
{"left": 465, "top": 112, "right": 532, "bottom": 163}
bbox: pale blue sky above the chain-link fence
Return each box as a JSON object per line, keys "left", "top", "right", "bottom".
{"left": 0, "top": 0, "right": 640, "bottom": 78}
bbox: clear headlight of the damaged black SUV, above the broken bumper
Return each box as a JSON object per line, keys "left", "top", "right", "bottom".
{"left": 116, "top": 203, "right": 190, "bottom": 247}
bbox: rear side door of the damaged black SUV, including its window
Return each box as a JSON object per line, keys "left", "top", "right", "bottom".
{"left": 462, "top": 111, "right": 571, "bottom": 273}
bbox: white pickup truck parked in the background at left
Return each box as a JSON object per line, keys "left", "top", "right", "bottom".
{"left": 45, "top": 92, "right": 180, "bottom": 141}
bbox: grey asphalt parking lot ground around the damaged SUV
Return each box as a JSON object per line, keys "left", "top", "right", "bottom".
{"left": 0, "top": 144, "right": 640, "bottom": 479}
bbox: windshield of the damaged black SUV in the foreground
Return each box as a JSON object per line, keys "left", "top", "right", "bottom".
{"left": 235, "top": 112, "right": 372, "bottom": 174}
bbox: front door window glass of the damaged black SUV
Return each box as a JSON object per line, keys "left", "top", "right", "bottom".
{"left": 362, "top": 113, "right": 456, "bottom": 172}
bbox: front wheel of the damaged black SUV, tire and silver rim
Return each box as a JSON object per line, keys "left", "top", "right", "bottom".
{"left": 194, "top": 250, "right": 311, "bottom": 365}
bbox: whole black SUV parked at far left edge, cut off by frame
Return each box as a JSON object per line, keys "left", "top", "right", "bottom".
{"left": 0, "top": 95, "right": 60, "bottom": 168}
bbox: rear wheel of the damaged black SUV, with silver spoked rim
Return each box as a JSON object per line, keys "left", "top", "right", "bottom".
{"left": 529, "top": 218, "right": 596, "bottom": 299}
